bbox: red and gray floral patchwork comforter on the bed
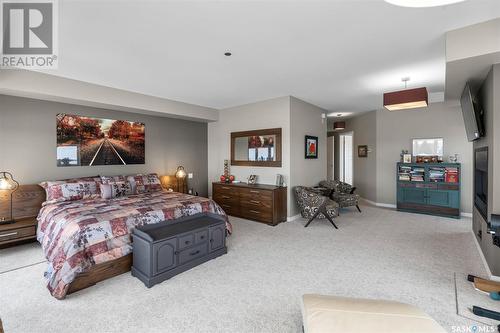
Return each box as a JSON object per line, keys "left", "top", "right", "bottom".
{"left": 37, "top": 191, "right": 231, "bottom": 299}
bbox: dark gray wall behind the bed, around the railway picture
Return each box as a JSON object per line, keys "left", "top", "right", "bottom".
{"left": 0, "top": 95, "right": 207, "bottom": 196}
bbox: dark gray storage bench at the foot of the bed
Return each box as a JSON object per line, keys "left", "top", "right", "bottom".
{"left": 132, "top": 214, "right": 227, "bottom": 288}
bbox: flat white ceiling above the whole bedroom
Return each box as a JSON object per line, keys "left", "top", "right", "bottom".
{"left": 42, "top": 0, "right": 500, "bottom": 112}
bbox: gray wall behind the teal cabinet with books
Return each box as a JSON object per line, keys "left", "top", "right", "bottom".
{"left": 377, "top": 102, "right": 472, "bottom": 213}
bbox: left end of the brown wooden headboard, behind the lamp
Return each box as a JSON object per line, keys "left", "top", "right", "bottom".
{"left": 0, "top": 185, "right": 45, "bottom": 219}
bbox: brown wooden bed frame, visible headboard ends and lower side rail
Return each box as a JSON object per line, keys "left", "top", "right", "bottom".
{"left": 11, "top": 176, "right": 187, "bottom": 295}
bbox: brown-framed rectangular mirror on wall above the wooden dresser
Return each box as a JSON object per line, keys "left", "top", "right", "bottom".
{"left": 231, "top": 128, "right": 281, "bottom": 167}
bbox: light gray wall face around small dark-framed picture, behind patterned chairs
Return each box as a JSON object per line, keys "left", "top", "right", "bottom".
{"left": 288, "top": 97, "right": 327, "bottom": 216}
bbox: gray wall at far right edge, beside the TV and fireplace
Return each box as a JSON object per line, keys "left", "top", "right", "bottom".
{"left": 473, "top": 64, "right": 500, "bottom": 276}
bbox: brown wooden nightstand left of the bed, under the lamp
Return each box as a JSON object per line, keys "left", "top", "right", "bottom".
{"left": 0, "top": 217, "right": 37, "bottom": 248}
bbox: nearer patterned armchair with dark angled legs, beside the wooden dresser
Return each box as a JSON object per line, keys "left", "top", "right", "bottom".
{"left": 294, "top": 186, "right": 339, "bottom": 229}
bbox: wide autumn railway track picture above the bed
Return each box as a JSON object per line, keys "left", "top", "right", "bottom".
{"left": 57, "top": 113, "right": 145, "bottom": 167}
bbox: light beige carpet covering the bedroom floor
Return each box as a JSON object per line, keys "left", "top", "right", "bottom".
{"left": 0, "top": 206, "right": 491, "bottom": 333}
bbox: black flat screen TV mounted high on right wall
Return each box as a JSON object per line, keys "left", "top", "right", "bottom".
{"left": 460, "top": 83, "right": 484, "bottom": 141}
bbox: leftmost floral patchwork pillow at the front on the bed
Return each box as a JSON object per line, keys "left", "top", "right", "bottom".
{"left": 40, "top": 177, "right": 101, "bottom": 203}
